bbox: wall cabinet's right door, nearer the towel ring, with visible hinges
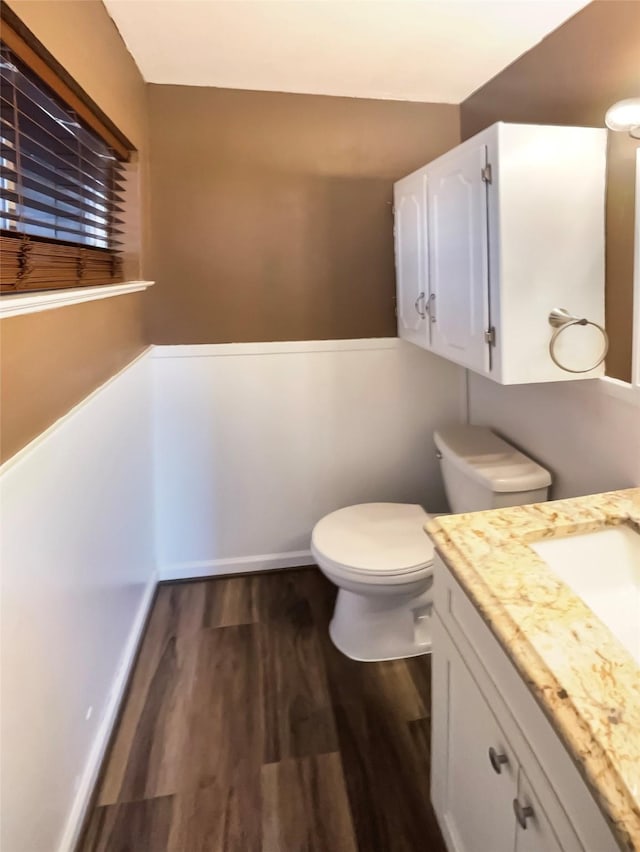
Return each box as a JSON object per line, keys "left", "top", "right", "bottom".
{"left": 427, "top": 145, "right": 490, "bottom": 373}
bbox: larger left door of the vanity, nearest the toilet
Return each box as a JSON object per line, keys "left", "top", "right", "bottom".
{"left": 431, "top": 616, "right": 516, "bottom": 852}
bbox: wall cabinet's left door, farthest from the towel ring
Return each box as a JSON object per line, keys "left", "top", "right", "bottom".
{"left": 393, "top": 170, "right": 429, "bottom": 348}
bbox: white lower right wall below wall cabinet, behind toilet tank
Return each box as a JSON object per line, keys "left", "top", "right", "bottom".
{"left": 469, "top": 373, "right": 640, "bottom": 500}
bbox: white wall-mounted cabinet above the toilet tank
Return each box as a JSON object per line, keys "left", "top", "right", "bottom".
{"left": 394, "top": 123, "right": 606, "bottom": 384}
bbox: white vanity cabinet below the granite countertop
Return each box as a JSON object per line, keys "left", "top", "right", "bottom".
{"left": 431, "top": 556, "right": 619, "bottom": 852}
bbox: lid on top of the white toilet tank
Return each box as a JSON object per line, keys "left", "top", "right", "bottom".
{"left": 433, "top": 424, "right": 551, "bottom": 493}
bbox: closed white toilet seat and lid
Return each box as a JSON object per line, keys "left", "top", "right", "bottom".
{"left": 311, "top": 503, "right": 434, "bottom": 584}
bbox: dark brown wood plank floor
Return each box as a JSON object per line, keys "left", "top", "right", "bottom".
{"left": 79, "top": 568, "right": 444, "bottom": 852}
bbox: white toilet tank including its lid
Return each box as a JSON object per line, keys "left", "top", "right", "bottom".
{"left": 433, "top": 425, "right": 551, "bottom": 514}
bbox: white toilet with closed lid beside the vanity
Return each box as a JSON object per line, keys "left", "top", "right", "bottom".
{"left": 311, "top": 425, "right": 551, "bottom": 662}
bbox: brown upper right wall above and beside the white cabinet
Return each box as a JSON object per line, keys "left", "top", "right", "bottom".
{"left": 461, "top": 0, "right": 640, "bottom": 381}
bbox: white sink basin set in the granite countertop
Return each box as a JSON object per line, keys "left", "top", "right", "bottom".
{"left": 530, "top": 525, "right": 640, "bottom": 664}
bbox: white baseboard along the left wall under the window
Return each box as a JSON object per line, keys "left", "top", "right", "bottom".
{"left": 58, "top": 573, "right": 158, "bottom": 852}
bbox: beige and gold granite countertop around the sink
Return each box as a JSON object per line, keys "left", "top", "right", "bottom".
{"left": 426, "top": 488, "right": 640, "bottom": 852}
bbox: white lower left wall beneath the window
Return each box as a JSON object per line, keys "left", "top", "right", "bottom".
{"left": 0, "top": 354, "right": 156, "bottom": 852}
